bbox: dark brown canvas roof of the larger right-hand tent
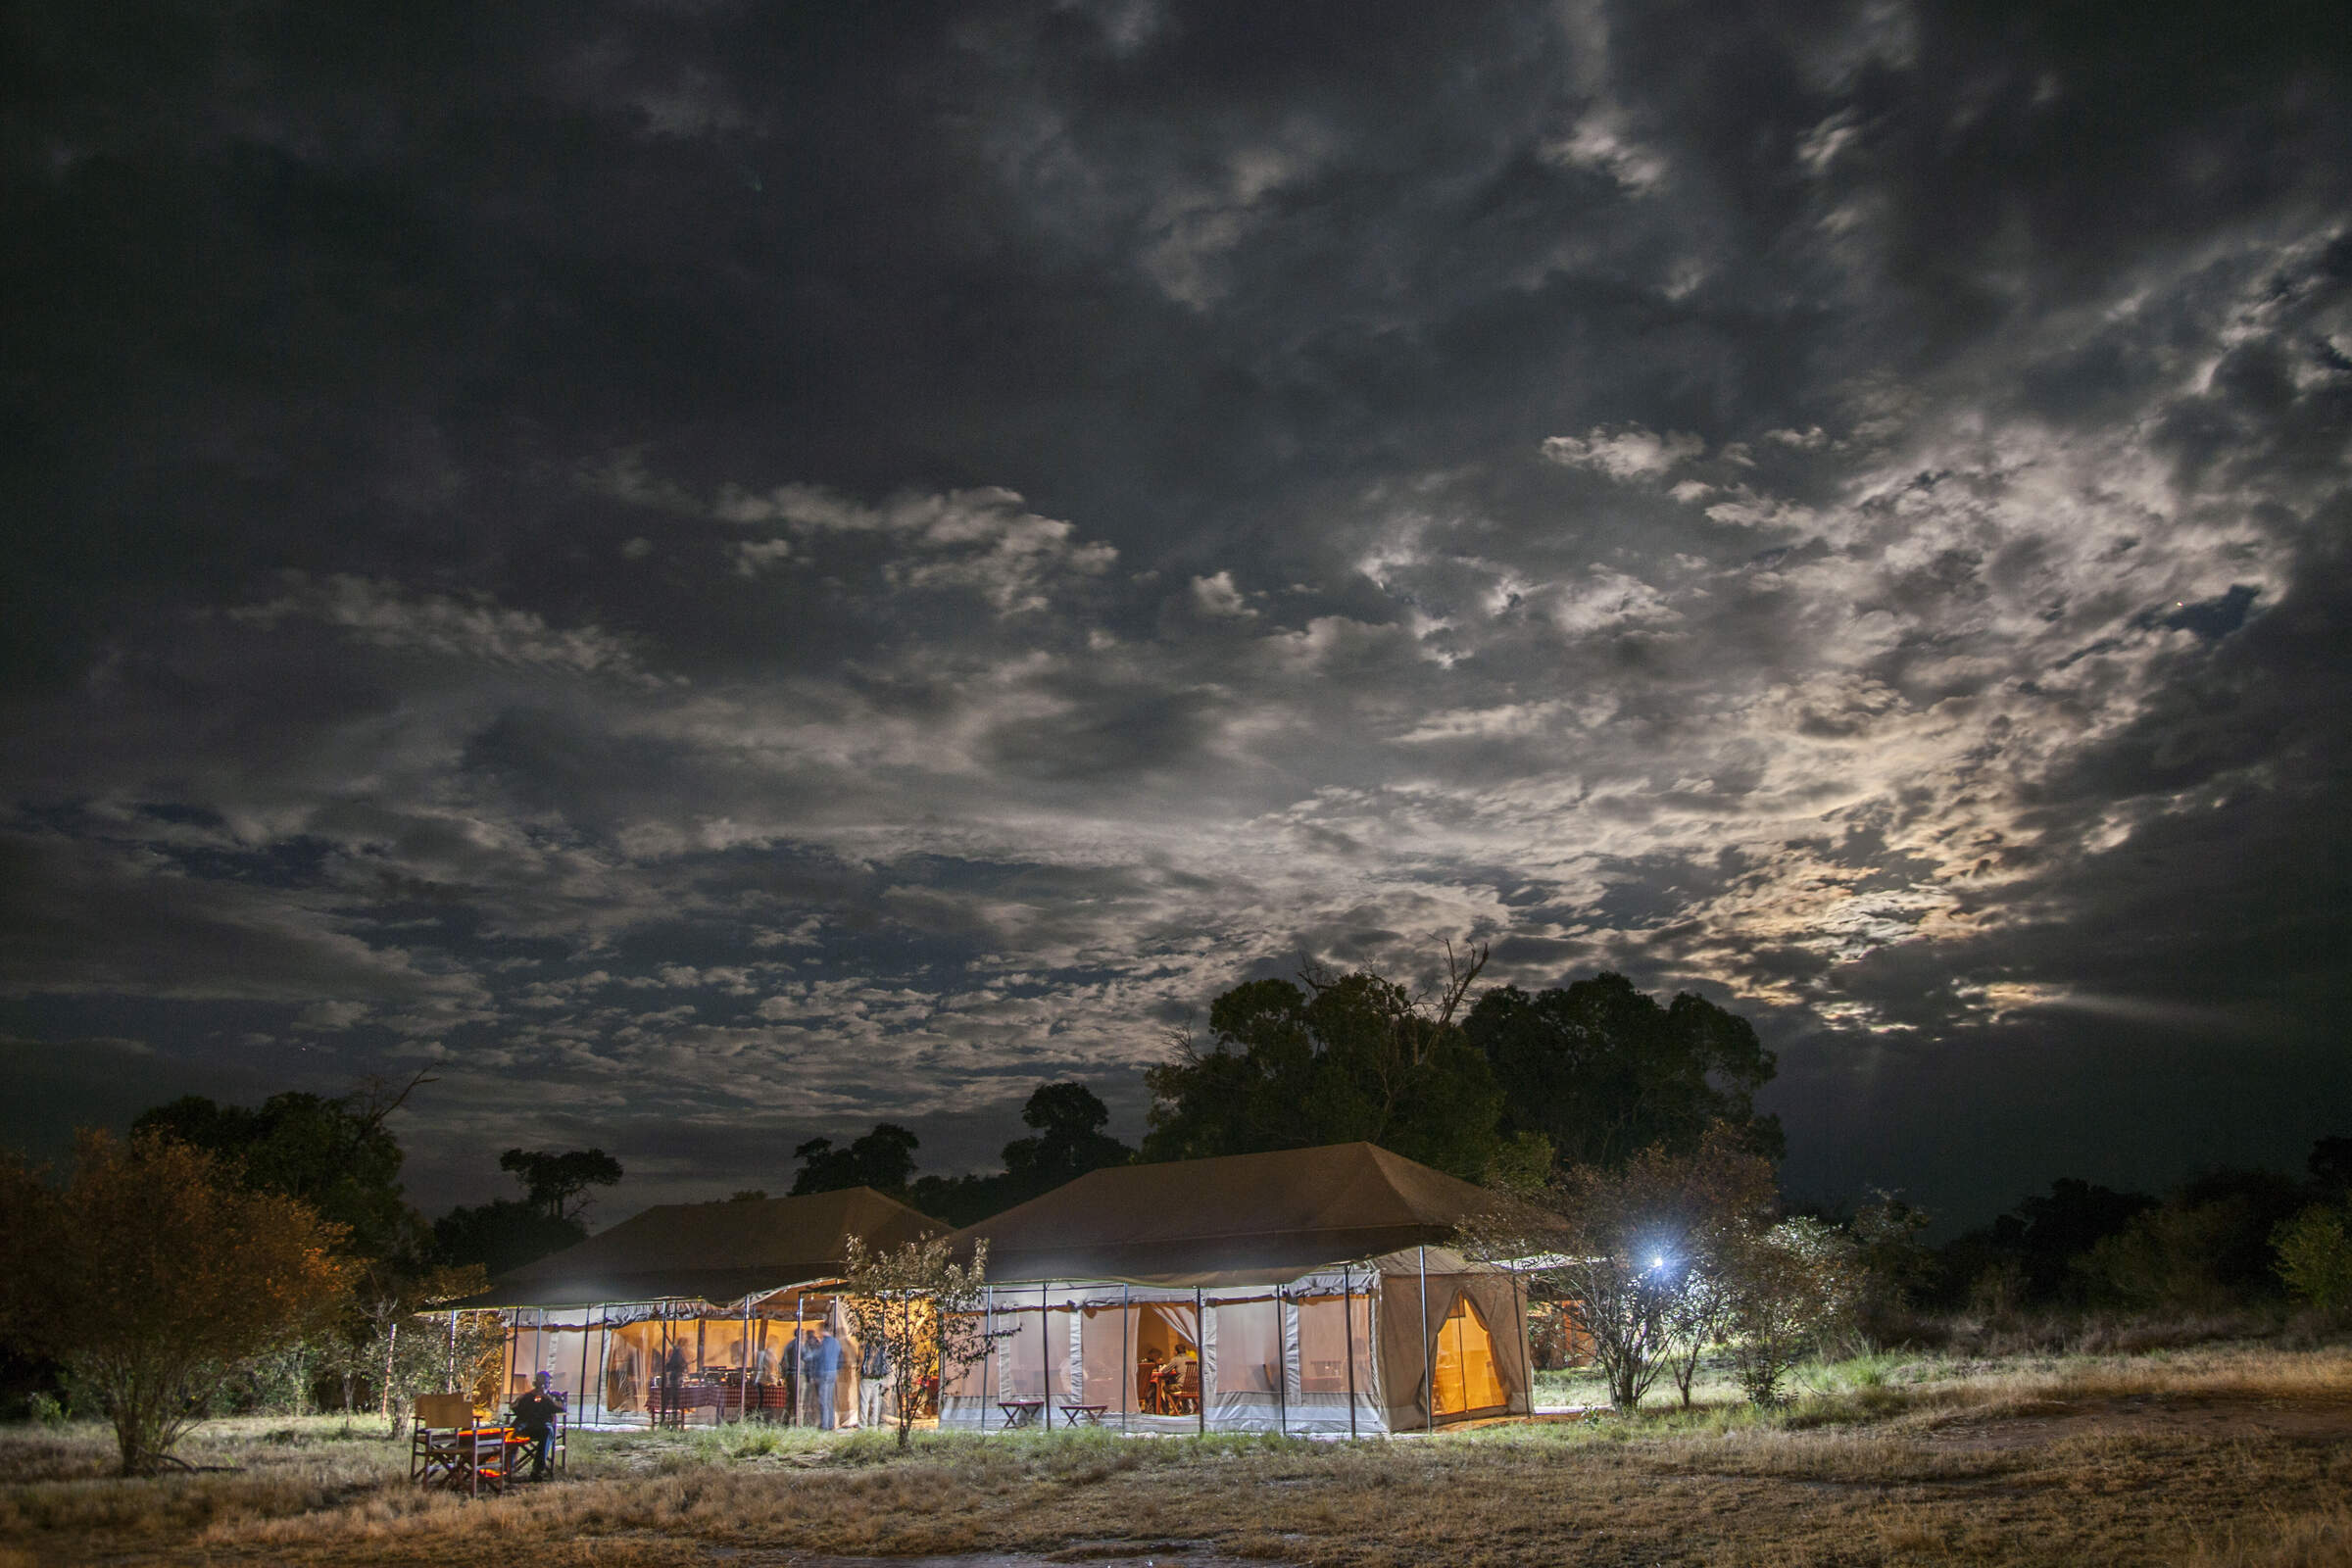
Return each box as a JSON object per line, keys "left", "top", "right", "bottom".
{"left": 955, "top": 1143, "right": 1552, "bottom": 1286}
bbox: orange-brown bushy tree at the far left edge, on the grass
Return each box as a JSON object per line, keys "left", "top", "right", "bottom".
{"left": 0, "top": 1131, "right": 348, "bottom": 1476}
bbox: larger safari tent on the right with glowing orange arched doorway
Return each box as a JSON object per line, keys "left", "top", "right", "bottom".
{"left": 941, "top": 1143, "right": 1531, "bottom": 1437}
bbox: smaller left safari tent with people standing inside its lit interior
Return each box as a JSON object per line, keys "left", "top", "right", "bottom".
{"left": 452, "top": 1187, "right": 946, "bottom": 1427}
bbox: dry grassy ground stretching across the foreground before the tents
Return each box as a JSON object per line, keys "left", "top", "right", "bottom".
{"left": 0, "top": 1348, "right": 2352, "bottom": 1568}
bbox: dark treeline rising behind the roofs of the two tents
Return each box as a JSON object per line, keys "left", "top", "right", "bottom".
{"left": 793, "top": 953, "right": 1786, "bottom": 1225}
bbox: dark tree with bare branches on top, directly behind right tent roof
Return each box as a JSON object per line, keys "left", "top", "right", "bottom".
{"left": 1143, "top": 950, "right": 1503, "bottom": 1183}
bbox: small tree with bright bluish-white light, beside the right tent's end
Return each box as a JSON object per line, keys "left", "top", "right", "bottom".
{"left": 1463, "top": 1124, "right": 1774, "bottom": 1410}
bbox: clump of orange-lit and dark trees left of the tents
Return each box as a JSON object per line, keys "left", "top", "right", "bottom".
{"left": 0, "top": 1074, "right": 621, "bottom": 1469}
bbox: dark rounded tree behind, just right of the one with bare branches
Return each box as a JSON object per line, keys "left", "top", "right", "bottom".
{"left": 1463, "top": 973, "right": 1783, "bottom": 1168}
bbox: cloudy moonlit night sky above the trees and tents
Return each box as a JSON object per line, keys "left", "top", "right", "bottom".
{"left": 0, "top": 0, "right": 2352, "bottom": 1222}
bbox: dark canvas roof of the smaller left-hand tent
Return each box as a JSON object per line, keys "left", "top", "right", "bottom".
{"left": 454, "top": 1187, "right": 946, "bottom": 1307}
